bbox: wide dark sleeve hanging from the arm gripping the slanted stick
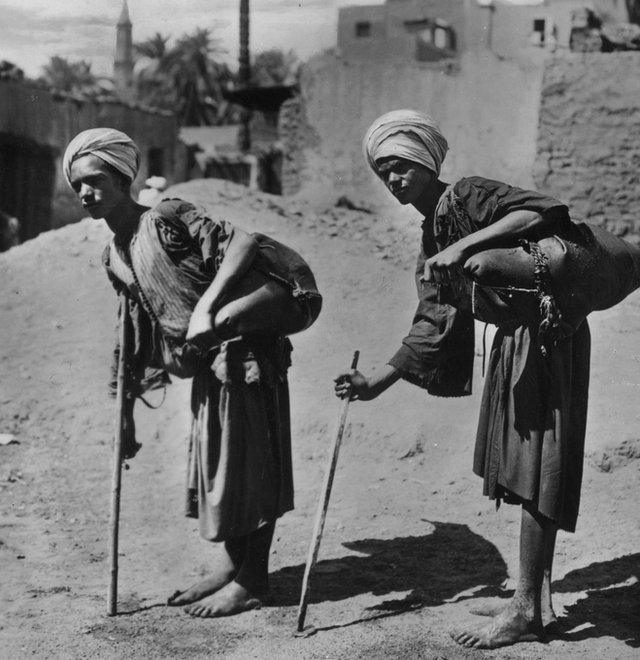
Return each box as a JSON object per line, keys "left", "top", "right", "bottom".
{"left": 389, "top": 242, "right": 474, "bottom": 396}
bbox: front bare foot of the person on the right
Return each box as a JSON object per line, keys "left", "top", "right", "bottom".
{"left": 450, "top": 608, "right": 542, "bottom": 649}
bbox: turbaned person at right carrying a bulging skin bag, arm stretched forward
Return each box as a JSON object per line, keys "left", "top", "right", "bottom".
{"left": 335, "top": 110, "right": 640, "bottom": 648}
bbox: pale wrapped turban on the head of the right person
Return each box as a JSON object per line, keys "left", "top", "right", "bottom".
{"left": 363, "top": 110, "right": 449, "bottom": 176}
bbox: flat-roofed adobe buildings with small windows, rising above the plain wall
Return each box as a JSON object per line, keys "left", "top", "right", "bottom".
{"left": 338, "top": 0, "right": 628, "bottom": 62}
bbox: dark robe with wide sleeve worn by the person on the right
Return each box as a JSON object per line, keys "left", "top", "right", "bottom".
{"left": 390, "top": 177, "right": 590, "bottom": 531}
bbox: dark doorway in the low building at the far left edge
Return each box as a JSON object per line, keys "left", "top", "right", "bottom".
{"left": 0, "top": 133, "right": 55, "bottom": 241}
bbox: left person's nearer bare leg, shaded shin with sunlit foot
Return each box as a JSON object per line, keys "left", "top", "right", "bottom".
{"left": 184, "top": 523, "right": 275, "bottom": 617}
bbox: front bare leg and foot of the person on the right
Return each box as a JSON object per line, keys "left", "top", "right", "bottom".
{"left": 451, "top": 506, "right": 555, "bottom": 649}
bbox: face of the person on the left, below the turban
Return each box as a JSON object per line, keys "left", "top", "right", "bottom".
{"left": 71, "top": 155, "right": 129, "bottom": 218}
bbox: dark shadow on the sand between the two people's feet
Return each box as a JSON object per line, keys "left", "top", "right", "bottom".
{"left": 270, "top": 522, "right": 507, "bottom": 624}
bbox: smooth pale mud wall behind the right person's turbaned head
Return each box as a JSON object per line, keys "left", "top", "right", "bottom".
{"left": 301, "top": 51, "right": 543, "bottom": 215}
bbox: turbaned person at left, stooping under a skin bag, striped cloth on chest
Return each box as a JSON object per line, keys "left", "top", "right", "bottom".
{"left": 63, "top": 128, "right": 322, "bottom": 617}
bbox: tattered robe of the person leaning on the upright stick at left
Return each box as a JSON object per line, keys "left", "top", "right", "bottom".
{"left": 104, "top": 200, "right": 321, "bottom": 541}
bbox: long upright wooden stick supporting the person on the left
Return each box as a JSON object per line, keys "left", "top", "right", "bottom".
{"left": 107, "top": 295, "right": 129, "bottom": 616}
